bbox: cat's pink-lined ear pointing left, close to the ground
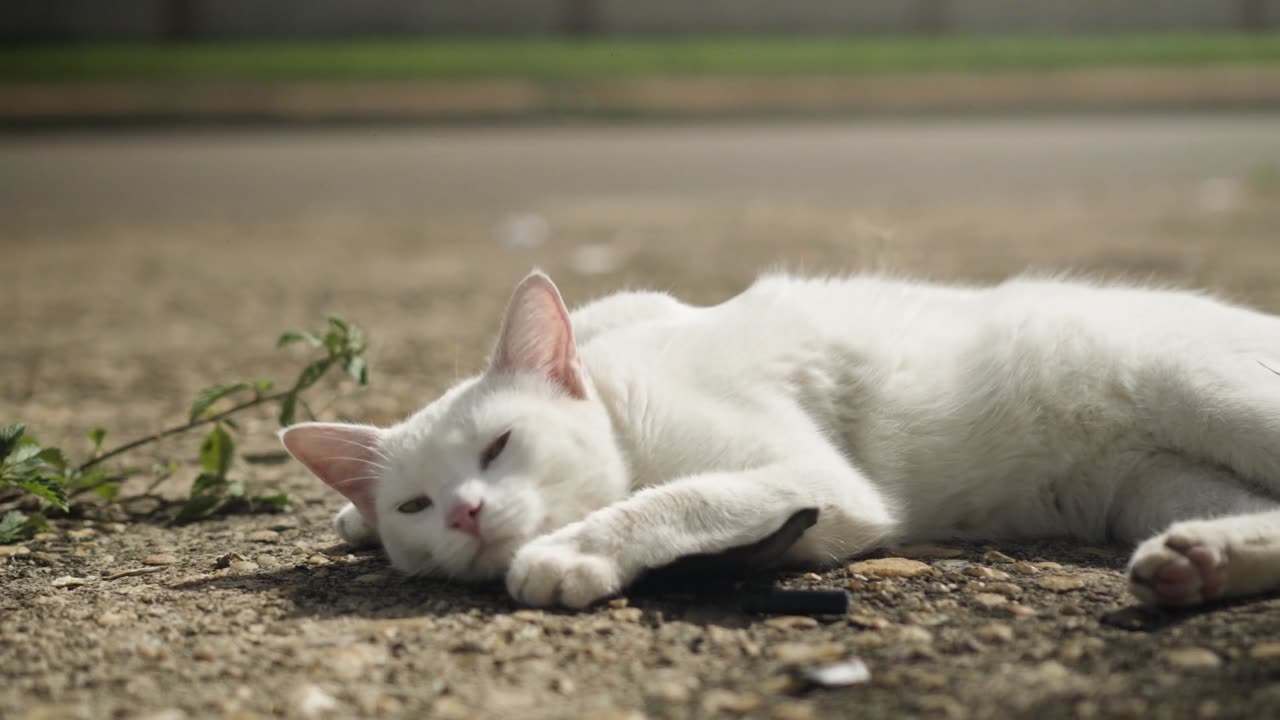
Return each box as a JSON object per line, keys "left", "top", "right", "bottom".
{"left": 280, "top": 423, "right": 381, "bottom": 517}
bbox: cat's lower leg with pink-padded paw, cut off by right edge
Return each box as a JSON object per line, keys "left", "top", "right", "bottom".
{"left": 1129, "top": 510, "right": 1280, "bottom": 606}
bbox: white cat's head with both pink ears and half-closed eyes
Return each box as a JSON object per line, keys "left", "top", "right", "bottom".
{"left": 280, "top": 272, "right": 627, "bottom": 579}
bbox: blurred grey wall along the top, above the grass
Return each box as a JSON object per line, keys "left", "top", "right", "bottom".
{"left": 0, "top": 0, "right": 1280, "bottom": 41}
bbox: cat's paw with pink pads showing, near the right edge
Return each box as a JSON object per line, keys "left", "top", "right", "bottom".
{"left": 1129, "top": 521, "right": 1229, "bottom": 607}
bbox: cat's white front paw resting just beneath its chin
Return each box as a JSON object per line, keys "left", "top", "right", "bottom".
{"left": 507, "top": 536, "right": 623, "bottom": 609}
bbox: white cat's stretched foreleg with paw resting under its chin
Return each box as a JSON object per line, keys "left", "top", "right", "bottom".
{"left": 507, "top": 454, "right": 895, "bottom": 607}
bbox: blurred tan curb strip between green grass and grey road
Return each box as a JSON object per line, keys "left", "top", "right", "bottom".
{"left": 0, "top": 67, "right": 1280, "bottom": 124}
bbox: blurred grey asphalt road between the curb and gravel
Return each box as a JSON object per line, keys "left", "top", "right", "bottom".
{"left": 0, "top": 114, "right": 1280, "bottom": 222}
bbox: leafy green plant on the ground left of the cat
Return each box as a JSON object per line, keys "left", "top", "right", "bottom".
{"left": 0, "top": 318, "right": 369, "bottom": 542}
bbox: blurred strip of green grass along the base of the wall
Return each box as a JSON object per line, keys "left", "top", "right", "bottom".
{"left": 0, "top": 33, "right": 1280, "bottom": 83}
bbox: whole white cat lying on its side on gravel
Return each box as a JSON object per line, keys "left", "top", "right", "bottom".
{"left": 282, "top": 273, "right": 1280, "bottom": 607}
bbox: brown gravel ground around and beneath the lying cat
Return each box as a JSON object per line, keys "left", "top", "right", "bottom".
{"left": 0, "top": 124, "right": 1280, "bottom": 720}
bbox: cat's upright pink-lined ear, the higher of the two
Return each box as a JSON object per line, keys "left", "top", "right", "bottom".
{"left": 492, "top": 270, "right": 586, "bottom": 400}
